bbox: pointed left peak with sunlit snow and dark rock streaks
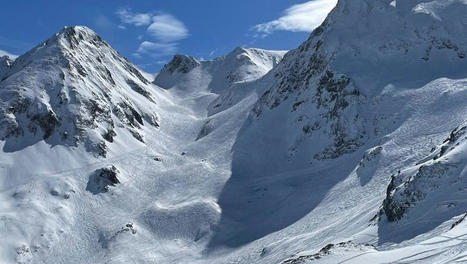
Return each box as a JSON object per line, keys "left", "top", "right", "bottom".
{"left": 0, "top": 26, "right": 158, "bottom": 156}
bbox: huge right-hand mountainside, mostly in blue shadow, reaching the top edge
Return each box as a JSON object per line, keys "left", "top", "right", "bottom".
{"left": 203, "top": 0, "right": 467, "bottom": 263}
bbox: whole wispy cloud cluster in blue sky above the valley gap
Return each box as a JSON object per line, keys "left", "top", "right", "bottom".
{"left": 117, "top": 8, "right": 189, "bottom": 58}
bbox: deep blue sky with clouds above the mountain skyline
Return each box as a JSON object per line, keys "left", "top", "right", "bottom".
{"left": 0, "top": 0, "right": 337, "bottom": 72}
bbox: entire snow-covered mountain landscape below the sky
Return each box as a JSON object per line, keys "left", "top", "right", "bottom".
{"left": 0, "top": 0, "right": 467, "bottom": 264}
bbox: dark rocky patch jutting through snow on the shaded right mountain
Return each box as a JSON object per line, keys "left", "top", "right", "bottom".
{"left": 253, "top": 38, "right": 367, "bottom": 160}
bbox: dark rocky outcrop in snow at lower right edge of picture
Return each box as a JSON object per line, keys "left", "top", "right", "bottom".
{"left": 383, "top": 123, "right": 467, "bottom": 221}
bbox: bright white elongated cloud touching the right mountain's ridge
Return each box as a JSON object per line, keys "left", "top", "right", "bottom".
{"left": 253, "top": 0, "right": 337, "bottom": 37}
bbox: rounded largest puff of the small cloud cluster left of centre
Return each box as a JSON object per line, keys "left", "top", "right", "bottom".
{"left": 148, "top": 14, "right": 188, "bottom": 42}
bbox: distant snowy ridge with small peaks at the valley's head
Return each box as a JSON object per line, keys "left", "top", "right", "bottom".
{"left": 154, "top": 47, "right": 285, "bottom": 94}
